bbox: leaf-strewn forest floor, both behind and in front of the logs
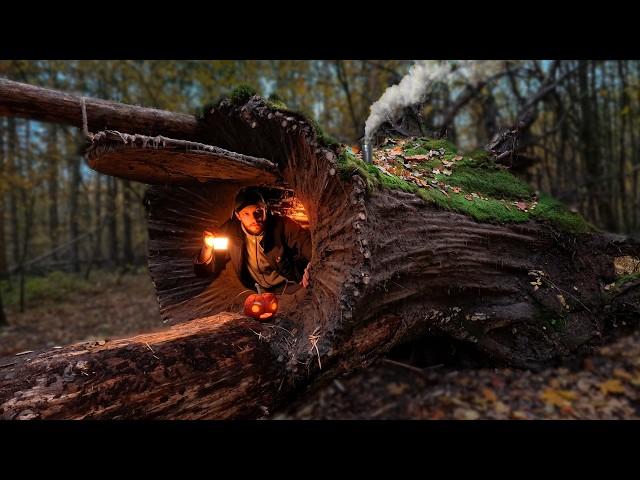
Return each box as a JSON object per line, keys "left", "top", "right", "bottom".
{"left": 0, "top": 271, "right": 640, "bottom": 419}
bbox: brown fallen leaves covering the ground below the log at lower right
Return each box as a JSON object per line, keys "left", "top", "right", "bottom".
{"left": 275, "top": 332, "right": 640, "bottom": 420}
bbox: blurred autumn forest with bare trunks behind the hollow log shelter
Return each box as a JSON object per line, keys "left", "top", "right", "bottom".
{"left": 0, "top": 60, "right": 640, "bottom": 418}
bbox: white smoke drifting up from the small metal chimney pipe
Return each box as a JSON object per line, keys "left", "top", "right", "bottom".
{"left": 364, "top": 60, "right": 501, "bottom": 139}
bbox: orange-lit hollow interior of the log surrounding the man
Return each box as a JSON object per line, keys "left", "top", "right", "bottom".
{"left": 146, "top": 182, "right": 313, "bottom": 323}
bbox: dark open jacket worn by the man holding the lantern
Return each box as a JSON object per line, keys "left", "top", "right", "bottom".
{"left": 193, "top": 213, "right": 311, "bottom": 293}
